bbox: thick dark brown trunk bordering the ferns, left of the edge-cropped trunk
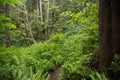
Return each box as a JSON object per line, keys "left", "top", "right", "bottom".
{"left": 99, "top": 0, "right": 114, "bottom": 77}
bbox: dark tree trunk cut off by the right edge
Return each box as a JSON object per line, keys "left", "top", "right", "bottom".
{"left": 112, "top": 0, "right": 120, "bottom": 54}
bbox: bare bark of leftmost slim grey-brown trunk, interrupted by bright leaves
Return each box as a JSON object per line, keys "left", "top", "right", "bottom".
{"left": 5, "top": 4, "right": 11, "bottom": 47}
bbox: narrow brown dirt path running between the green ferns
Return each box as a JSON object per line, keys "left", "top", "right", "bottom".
{"left": 49, "top": 66, "right": 62, "bottom": 80}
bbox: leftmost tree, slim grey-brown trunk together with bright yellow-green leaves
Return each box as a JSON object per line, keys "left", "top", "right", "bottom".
{"left": 0, "top": 0, "right": 22, "bottom": 47}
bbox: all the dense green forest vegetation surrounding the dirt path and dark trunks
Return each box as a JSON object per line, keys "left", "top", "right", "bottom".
{"left": 0, "top": 0, "right": 120, "bottom": 80}
